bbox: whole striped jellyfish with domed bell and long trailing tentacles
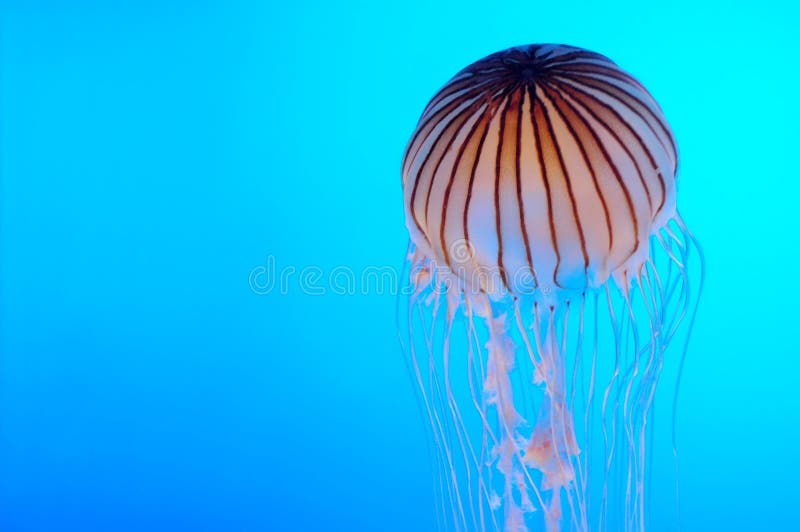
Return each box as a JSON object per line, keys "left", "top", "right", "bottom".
{"left": 398, "top": 44, "right": 703, "bottom": 532}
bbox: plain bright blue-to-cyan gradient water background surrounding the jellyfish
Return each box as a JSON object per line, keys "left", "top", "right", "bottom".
{"left": 0, "top": 0, "right": 800, "bottom": 532}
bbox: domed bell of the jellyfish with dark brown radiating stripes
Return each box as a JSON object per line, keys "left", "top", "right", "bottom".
{"left": 403, "top": 45, "right": 677, "bottom": 300}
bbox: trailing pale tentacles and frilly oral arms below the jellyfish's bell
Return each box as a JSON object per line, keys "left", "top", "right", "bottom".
{"left": 401, "top": 217, "right": 702, "bottom": 531}
